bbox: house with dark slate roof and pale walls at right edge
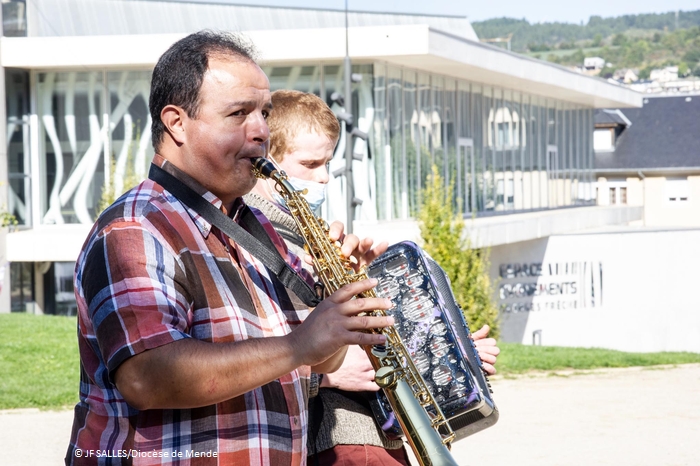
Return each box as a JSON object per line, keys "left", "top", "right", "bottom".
{"left": 594, "top": 94, "right": 700, "bottom": 227}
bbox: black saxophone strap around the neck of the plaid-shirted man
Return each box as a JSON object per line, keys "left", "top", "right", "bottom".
{"left": 148, "top": 165, "right": 320, "bottom": 307}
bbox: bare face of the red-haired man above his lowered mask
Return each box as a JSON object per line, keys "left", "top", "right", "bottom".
{"left": 279, "top": 132, "right": 335, "bottom": 184}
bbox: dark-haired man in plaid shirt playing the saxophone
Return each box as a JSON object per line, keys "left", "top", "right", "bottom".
{"left": 65, "top": 31, "right": 393, "bottom": 466}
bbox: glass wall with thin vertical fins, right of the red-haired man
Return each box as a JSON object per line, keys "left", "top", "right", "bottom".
{"left": 374, "top": 64, "right": 594, "bottom": 220}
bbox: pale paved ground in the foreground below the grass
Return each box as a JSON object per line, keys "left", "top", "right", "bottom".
{"left": 0, "top": 364, "right": 700, "bottom": 466}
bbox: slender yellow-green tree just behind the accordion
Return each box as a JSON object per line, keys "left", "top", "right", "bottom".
{"left": 418, "top": 166, "right": 499, "bottom": 337}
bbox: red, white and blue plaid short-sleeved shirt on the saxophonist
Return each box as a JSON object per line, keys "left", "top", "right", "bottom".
{"left": 66, "top": 155, "right": 310, "bottom": 466}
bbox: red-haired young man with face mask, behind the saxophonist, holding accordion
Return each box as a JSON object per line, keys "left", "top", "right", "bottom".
{"left": 244, "top": 90, "right": 499, "bottom": 465}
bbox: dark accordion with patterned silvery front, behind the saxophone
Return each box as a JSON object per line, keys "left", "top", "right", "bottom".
{"left": 367, "top": 241, "right": 498, "bottom": 440}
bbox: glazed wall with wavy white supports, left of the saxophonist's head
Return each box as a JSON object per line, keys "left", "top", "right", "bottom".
{"left": 35, "top": 71, "right": 153, "bottom": 228}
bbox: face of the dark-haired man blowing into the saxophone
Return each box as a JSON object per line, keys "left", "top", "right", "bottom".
{"left": 182, "top": 57, "right": 272, "bottom": 206}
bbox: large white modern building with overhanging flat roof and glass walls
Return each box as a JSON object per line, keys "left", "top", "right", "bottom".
{"left": 0, "top": 0, "right": 642, "bottom": 350}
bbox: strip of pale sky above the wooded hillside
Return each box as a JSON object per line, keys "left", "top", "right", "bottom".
{"left": 212, "top": 0, "right": 700, "bottom": 24}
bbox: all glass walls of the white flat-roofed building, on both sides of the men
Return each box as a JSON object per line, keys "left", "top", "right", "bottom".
{"left": 6, "top": 63, "right": 594, "bottom": 229}
